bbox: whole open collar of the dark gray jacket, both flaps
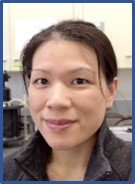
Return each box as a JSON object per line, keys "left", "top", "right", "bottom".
{"left": 15, "top": 123, "right": 111, "bottom": 180}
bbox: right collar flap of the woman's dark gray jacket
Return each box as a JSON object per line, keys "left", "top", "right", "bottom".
{"left": 84, "top": 122, "right": 112, "bottom": 180}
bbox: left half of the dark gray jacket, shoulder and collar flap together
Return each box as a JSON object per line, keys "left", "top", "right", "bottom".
{"left": 3, "top": 132, "right": 50, "bottom": 181}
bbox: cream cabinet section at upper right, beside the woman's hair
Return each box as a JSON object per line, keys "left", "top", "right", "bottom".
{"left": 74, "top": 3, "right": 132, "bottom": 68}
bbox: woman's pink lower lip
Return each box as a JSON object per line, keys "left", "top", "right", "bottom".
{"left": 46, "top": 123, "right": 73, "bottom": 131}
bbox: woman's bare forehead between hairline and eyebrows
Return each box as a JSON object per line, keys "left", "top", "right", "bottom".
{"left": 32, "top": 40, "right": 98, "bottom": 73}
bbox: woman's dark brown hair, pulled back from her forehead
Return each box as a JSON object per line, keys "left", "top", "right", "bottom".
{"left": 21, "top": 20, "right": 117, "bottom": 89}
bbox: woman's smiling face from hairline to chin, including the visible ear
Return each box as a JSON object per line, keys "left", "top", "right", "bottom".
{"left": 28, "top": 40, "right": 114, "bottom": 150}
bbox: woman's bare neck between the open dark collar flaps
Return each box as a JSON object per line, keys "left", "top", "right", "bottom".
{"left": 49, "top": 136, "right": 96, "bottom": 180}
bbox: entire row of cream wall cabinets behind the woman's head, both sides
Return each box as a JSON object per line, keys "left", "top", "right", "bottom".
{"left": 3, "top": 3, "right": 132, "bottom": 71}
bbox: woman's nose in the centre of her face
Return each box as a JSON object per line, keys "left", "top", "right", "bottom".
{"left": 46, "top": 84, "right": 71, "bottom": 110}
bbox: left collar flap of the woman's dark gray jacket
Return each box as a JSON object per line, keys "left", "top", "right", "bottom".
{"left": 15, "top": 131, "right": 51, "bottom": 180}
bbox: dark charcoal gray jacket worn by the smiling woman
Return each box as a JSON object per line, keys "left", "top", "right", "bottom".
{"left": 3, "top": 123, "right": 132, "bottom": 181}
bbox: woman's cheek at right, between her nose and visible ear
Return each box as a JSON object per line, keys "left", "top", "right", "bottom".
{"left": 74, "top": 90, "right": 106, "bottom": 129}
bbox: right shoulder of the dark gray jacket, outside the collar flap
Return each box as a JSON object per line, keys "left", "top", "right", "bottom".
{"left": 104, "top": 131, "right": 132, "bottom": 180}
